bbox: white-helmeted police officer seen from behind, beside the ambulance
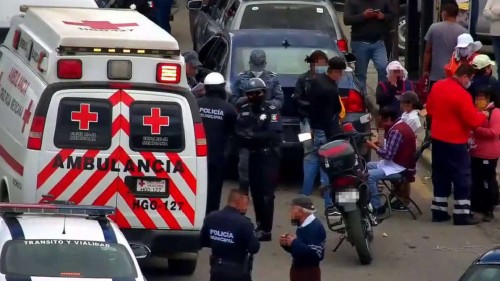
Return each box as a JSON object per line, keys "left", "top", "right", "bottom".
{"left": 198, "top": 72, "right": 236, "bottom": 214}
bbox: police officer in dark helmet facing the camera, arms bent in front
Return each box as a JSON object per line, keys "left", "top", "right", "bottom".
{"left": 236, "top": 78, "right": 282, "bottom": 241}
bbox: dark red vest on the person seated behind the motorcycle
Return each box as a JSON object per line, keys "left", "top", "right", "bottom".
{"left": 389, "top": 122, "right": 417, "bottom": 182}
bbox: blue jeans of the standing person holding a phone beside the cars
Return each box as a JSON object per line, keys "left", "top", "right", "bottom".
{"left": 351, "top": 40, "right": 388, "bottom": 92}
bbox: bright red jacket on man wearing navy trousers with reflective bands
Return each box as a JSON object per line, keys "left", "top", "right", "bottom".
{"left": 426, "top": 78, "right": 486, "bottom": 144}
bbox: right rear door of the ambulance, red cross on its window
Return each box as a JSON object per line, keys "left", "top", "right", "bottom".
{"left": 117, "top": 89, "right": 200, "bottom": 230}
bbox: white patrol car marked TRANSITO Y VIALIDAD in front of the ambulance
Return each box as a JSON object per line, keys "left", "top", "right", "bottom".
{"left": 0, "top": 203, "right": 150, "bottom": 281}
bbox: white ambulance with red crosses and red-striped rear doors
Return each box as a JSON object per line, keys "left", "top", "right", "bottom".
{"left": 0, "top": 7, "right": 207, "bottom": 274}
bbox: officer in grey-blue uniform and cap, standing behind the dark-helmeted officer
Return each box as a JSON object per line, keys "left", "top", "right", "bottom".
{"left": 231, "top": 50, "right": 284, "bottom": 110}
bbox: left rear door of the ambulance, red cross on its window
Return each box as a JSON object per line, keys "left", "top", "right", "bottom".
{"left": 36, "top": 89, "right": 122, "bottom": 209}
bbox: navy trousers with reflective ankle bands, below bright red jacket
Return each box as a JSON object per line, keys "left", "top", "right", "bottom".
{"left": 431, "top": 140, "right": 472, "bottom": 224}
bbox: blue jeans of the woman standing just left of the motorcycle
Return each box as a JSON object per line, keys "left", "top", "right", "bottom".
{"left": 301, "top": 130, "right": 333, "bottom": 208}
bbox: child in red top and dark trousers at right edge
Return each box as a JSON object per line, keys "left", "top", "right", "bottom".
{"left": 469, "top": 88, "right": 500, "bottom": 221}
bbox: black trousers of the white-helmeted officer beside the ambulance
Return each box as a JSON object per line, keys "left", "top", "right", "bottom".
{"left": 206, "top": 160, "right": 224, "bottom": 214}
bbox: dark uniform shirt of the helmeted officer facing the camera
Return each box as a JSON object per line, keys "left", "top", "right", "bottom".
{"left": 236, "top": 102, "right": 283, "bottom": 149}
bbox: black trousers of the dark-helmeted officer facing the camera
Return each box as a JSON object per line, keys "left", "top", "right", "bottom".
{"left": 248, "top": 149, "right": 279, "bottom": 232}
